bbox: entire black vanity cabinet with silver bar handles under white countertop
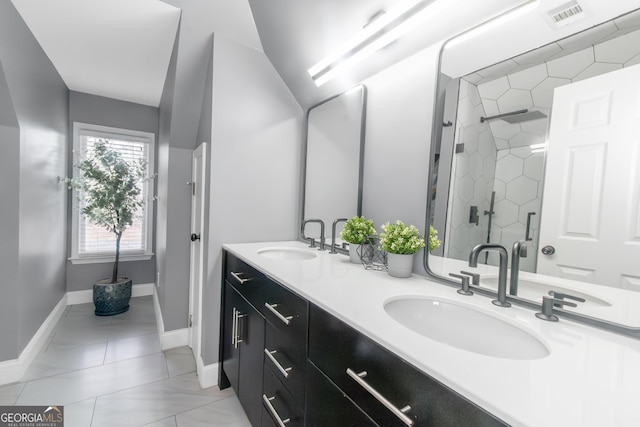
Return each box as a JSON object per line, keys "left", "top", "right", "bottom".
{"left": 219, "top": 252, "right": 505, "bottom": 427}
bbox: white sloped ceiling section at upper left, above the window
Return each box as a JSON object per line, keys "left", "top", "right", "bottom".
{"left": 12, "top": 0, "right": 180, "bottom": 106}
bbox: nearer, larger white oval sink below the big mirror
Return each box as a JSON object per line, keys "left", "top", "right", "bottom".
{"left": 384, "top": 297, "right": 550, "bottom": 360}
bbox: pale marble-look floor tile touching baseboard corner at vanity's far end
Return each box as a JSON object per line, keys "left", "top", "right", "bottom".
{"left": 92, "top": 373, "right": 231, "bottom": 427}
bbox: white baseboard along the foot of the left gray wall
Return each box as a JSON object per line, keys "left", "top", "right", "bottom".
{"left": 0, "top": 294, "right": 68, "bottom": 385}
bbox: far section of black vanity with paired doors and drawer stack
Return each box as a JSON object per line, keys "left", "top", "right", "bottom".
{"left": 219, "top": 253, "right": 308, "bottom": 426}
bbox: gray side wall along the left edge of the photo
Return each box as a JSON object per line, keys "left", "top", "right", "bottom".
{"left": 0, "top": 1, "right": 68, "bottom": 360}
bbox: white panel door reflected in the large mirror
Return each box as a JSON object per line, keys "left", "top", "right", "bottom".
{"left": 537, "top": 66, "right": 640, "bottom": 290}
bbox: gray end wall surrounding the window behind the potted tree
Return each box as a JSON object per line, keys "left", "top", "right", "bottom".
{"left": 67, "top": 91, "right": 158, "bottom": 291}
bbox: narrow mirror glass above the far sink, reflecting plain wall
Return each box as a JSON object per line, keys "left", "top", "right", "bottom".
{"left": 302, "top": 85, "right": 366, "bottom": 247}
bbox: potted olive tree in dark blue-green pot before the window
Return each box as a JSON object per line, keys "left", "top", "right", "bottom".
{"left": 67, "top": 139, "right": 147, "bottom": 316}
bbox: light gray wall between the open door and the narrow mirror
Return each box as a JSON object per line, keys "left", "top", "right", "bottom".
{"left": 203, "top": 35, "right": 303, "bottom": 364}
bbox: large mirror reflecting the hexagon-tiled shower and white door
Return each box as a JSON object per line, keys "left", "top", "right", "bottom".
{"left": 425, "top": 10, "right": 640, "bottom": 327}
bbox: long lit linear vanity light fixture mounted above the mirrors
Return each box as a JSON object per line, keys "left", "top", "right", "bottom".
{"left": 308, "top": 0, "right": 447, "bottom": 86}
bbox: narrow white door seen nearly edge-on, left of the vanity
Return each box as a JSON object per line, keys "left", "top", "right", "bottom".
{"left": 189, "top": 142, "right": 207, "bottom": 364}
